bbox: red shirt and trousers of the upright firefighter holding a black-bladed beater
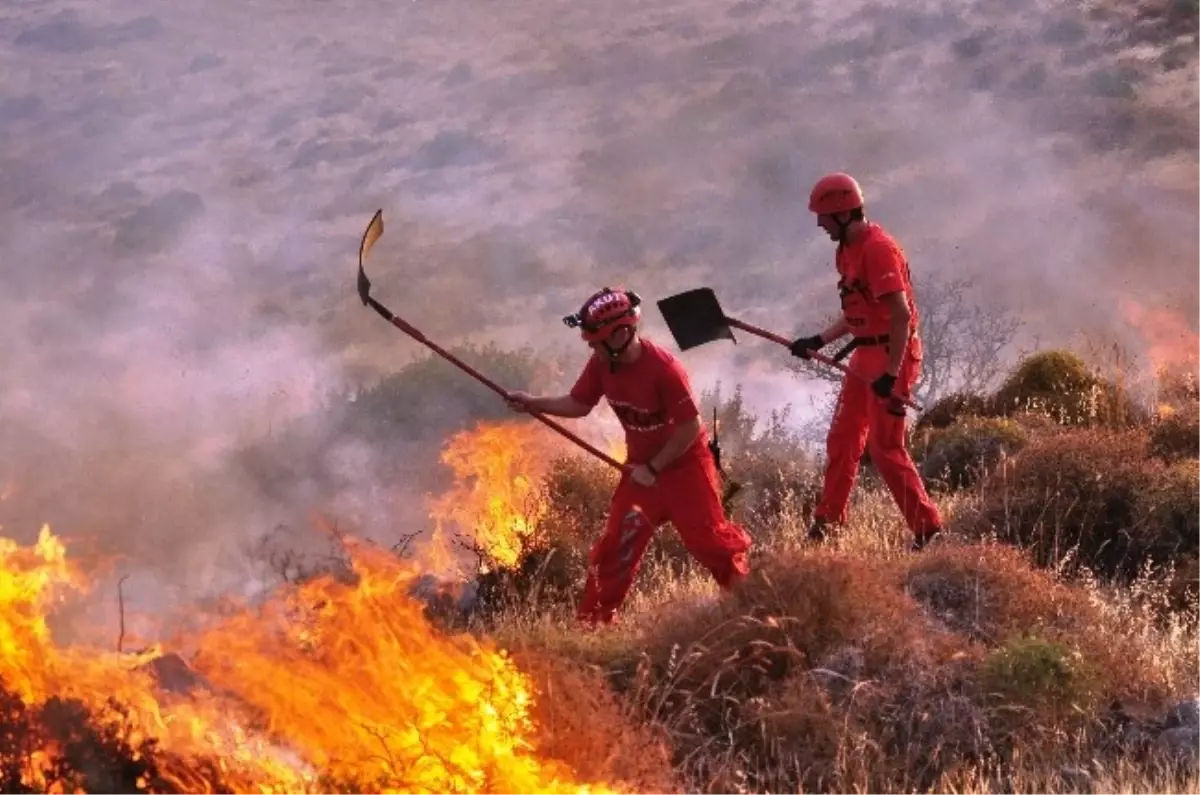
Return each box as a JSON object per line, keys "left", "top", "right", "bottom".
{"left": 814, "top": 222, "right": 942, "bottom": 538}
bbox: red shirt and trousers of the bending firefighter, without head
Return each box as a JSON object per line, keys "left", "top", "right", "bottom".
{"left": 570, "top": 339, "right": 750, "bottom": 624}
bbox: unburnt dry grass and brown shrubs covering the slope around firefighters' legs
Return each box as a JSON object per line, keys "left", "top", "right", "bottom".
{"left": 324, "top": 343, "right": 1200, "bottom": 793}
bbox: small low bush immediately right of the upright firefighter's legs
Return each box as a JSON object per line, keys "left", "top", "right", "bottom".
{"left": 912, "top": 418, "right": 1028, "bottom": 490}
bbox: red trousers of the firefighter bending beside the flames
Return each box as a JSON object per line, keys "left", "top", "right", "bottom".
{"left": 577, "top": 441, "right": 750, "bottom": 624}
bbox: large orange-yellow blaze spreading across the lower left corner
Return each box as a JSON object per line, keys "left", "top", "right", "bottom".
{"left": 0, "top": 528, "right": 633, "bottom": 795}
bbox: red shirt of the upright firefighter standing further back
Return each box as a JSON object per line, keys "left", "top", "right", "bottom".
{"left": 836, "top": 222, "right": 920, "bottom": 336}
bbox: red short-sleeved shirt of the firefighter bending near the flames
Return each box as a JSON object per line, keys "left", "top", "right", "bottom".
{"left": 570, "top": 339, "right": 708, "bottom": 464}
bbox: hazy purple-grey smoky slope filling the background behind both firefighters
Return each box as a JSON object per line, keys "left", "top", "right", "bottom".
{"left": 0, "top": 0, "right": 1200, "bottom": 610}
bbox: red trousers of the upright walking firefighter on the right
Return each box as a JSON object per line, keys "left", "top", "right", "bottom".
{"left": 814, "top": 345, "right": 942, "bottom": 538}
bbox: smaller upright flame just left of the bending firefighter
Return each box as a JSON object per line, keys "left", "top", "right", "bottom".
{"left": 426, "top": 420, "right": 568, "bottom": 576}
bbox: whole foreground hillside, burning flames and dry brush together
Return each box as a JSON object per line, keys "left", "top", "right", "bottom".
{"left": 0, "top": 352, "right": 1200, "bottom": 795}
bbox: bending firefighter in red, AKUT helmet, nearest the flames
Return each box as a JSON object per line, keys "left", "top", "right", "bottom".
{"left": 508, "top": 288, "right": 750, "bottom": 626}
